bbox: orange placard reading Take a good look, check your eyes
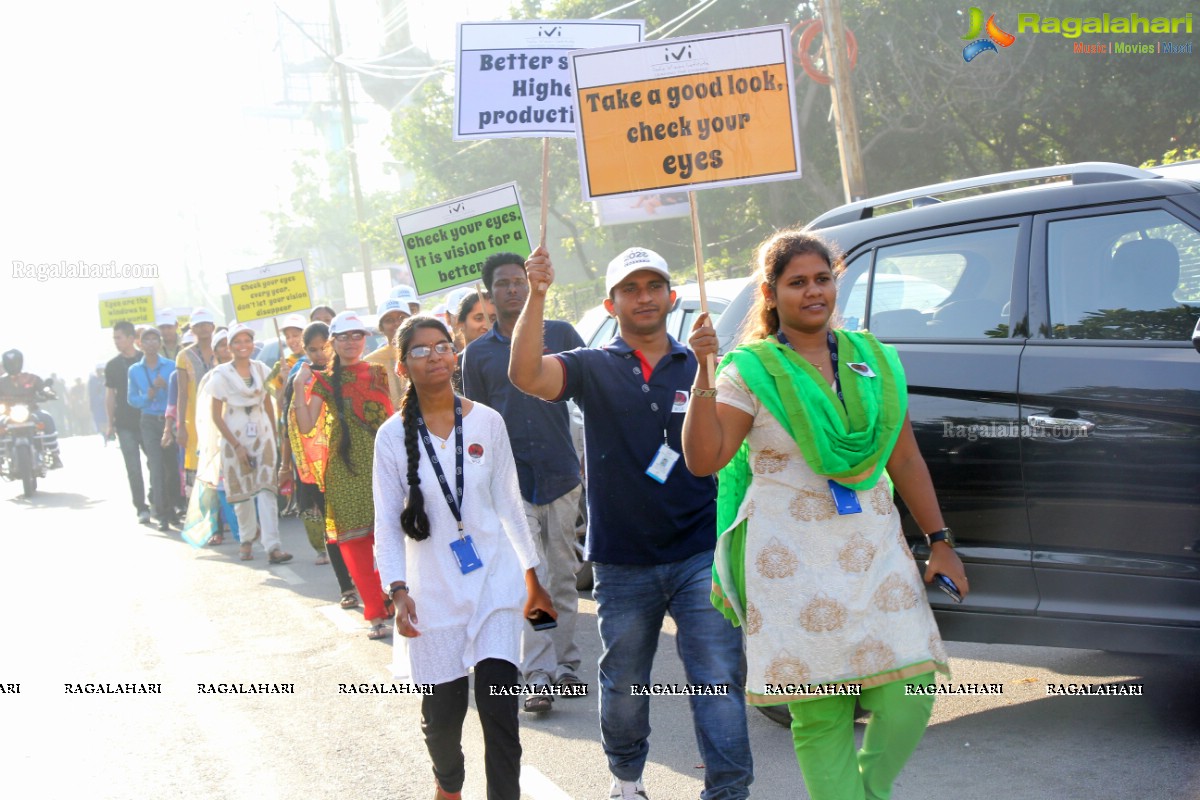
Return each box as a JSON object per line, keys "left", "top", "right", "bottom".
{"left": 571, "top": 26, "right": 800, "bottom": 199}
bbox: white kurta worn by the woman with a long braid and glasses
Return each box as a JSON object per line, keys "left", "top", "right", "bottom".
{"left": 374, "top": 403, "right": 538, "bottom": 684}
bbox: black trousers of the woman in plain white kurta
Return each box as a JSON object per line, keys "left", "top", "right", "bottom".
{"left": 421, "top": 658, "right": 521, "bottom": 800}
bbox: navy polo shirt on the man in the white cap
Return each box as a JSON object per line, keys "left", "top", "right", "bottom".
{"left": 557, "top": 336, "right": 716, "bottom": 565}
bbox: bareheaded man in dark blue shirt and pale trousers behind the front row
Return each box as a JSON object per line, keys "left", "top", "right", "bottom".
{"left": 462, "top": 253, "right": 583, "bottom": 711}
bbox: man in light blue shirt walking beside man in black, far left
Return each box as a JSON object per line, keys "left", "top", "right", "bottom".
{"left": 127, "top": 327, "right": 179, "bottom": 531}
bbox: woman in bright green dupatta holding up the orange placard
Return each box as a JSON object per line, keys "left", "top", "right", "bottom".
{"left": 683, "top": 230, "right": 970, "bottom": 800}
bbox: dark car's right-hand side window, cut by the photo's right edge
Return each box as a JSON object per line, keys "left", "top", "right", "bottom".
{"left": 1046, "top": 209, "right": 1200, "bottom": 342}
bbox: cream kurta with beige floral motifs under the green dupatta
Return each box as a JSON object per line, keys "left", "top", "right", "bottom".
{"left": 716, "top": 363, "right": 948, "bottom": 705}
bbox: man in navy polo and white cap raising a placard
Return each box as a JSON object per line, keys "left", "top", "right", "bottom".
{"left": 509, "top": 247, "right": 754, "bottom": 800}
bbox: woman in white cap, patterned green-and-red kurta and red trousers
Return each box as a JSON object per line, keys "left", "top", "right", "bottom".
{"left": 293, "top": 311, "right": 392, "bottom": 639}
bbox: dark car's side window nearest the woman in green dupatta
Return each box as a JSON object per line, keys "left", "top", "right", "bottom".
{"left": 841, "top": 227, "right": 1018, "bottom": 339}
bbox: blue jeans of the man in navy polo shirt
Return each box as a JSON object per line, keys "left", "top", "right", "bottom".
{"left": 593, "top": 552, "right": 754, "bottom": 800}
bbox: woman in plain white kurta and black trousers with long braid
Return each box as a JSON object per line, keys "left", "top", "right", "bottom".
{"left": 374, "top": 317, "right": 556, "bottom": 800}
